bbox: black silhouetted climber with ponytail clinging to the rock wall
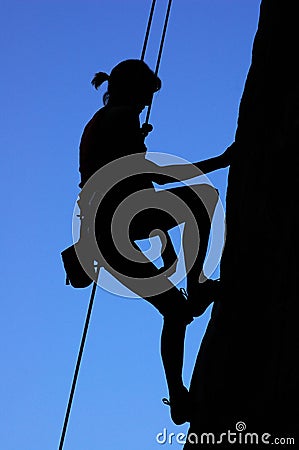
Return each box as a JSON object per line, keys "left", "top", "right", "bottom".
{"left": 79, "top": 60, "right": 233, "bottom": 424}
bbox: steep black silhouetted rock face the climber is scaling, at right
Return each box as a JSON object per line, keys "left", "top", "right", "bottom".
{"left": 185, "top": 0, "right": 299, "bottom": 449}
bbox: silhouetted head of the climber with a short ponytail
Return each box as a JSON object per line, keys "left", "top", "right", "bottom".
{"left": 92, "top": 59, "right": 161, "bottom": 109}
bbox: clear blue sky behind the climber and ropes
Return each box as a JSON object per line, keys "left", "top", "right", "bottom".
{"left": 0, "top": 0, "right": 260, "bottom": 450}
